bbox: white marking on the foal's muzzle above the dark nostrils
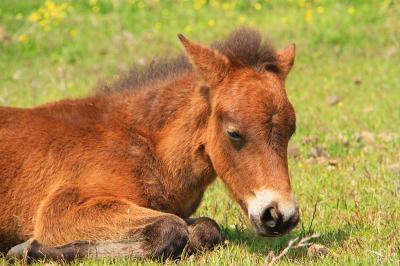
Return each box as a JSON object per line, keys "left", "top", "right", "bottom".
{"left": 246, "top": 189, "right": 297, "bottom": 222}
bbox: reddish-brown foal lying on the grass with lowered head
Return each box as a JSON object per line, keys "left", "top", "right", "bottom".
{"left": 0, "top": 29, "right": 299, "bottom": 260}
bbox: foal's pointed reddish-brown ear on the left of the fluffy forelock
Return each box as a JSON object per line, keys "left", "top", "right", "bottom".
{"left": 178, "top": 34, "right": 230, "bottom": 87}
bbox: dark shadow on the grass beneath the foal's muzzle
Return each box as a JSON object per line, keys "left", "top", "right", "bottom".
{"left": 222, "top": 225, "right": 355, "bottom": 258}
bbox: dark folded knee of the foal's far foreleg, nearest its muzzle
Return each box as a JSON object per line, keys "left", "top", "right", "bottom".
{"left": 185, "top": 217, "right": 222, "bottom": 254}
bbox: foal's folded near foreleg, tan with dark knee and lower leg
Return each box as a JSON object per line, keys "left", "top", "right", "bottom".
{"left": 9, "top": 188, "right": 189, "bottom": 260}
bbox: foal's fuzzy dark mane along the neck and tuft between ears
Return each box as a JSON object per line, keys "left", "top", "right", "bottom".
{"left": 98, "top": 28, "right": 276, "bottom": 94}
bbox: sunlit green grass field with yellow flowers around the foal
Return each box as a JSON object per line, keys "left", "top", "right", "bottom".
{"left": 0, "top": 0, "right": 400, "bottom": 265}
